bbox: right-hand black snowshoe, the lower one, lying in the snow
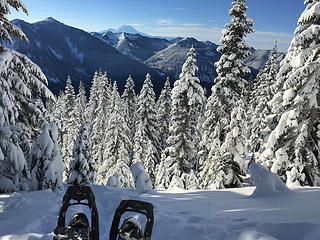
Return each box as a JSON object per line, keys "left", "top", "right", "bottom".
{"left": 109, "top": 200, "right": 154, "bottom": 240}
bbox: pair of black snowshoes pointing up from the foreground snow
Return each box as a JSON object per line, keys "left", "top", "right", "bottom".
{"left": 53, "top": 186, "right": 154, "bottom": 240}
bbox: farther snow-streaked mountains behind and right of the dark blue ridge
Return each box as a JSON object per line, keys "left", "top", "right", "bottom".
{"left": 91, "top": 31, "right": 284, "bottom": 86}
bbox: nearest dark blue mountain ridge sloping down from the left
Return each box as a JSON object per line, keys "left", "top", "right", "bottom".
{"left": 7, "top": 18, "right": 164, "bottom": 93}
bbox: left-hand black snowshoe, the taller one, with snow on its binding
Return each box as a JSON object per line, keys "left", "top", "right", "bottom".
{"left": 53, "top": 186, "right": 99, "bottom": 240}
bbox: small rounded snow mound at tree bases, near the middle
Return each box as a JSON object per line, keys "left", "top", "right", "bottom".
{"left": 130, "top": 162, "right": 152, "bottom": 193}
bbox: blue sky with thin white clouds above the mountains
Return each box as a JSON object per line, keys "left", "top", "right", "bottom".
{"left": 9, "top": 0, "right": 305, "bottom": 52}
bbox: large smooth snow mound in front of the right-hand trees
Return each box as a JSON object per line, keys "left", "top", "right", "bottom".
{"left": 249, "top": 163, "right": 291, "bottom": 198}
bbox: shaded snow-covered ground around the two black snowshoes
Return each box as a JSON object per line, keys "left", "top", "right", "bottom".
{"left": 0, "top": 185, "right": 320, "bottom": 240}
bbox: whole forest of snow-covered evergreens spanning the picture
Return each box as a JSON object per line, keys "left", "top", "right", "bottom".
{"left": 0, "top": 0, "right": 320, "bottom": 192}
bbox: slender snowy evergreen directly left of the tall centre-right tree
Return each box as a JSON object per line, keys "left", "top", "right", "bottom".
{"left": 156, "top": 77, "right": 171, "bottom": 150}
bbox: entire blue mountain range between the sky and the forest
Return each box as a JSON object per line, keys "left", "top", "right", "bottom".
{"left": 7, "top": 18, "right": 284, "bottom": 94}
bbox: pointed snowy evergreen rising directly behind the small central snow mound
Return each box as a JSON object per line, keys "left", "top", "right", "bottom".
{"left": 133, "top": 74, "right": 160, "bottom": 175}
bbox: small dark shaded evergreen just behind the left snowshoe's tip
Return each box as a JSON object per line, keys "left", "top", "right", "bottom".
{"left": 68, "top": 124, "right": 97, "bottom": 185}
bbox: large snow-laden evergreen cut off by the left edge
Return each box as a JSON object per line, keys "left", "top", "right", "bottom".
{"left": 0, "top": 0, "right": 55, "bottom": 191}
